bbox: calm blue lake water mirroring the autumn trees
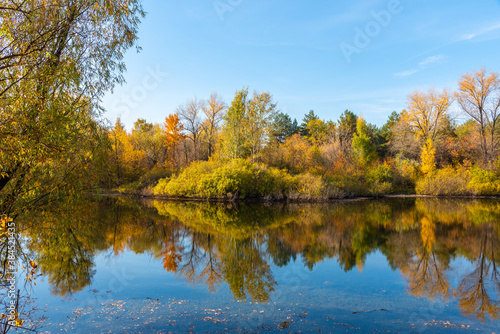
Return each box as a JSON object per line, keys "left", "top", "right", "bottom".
{"left": 5, "top": 198, "right": 500, "bottom": 333}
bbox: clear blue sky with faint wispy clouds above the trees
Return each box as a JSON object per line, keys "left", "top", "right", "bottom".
{"left": 103, "top": 0, "right": 500, "bottom": 129}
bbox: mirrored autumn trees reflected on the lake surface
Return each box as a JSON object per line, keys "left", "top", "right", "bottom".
{"left": 2, "top": 199, "right": 500, "bottom": 328}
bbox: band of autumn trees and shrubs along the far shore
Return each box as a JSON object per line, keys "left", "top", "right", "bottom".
{"left": 104, "top": 69, "right": 500, "bottom": 200}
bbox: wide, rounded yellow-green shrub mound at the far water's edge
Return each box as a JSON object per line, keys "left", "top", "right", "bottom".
{"left": 153, "top": 159, "right": 344, "bottom": 200}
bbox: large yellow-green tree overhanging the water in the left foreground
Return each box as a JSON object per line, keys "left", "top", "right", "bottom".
{"left": 0, "top": 0, "right": 144, "bottom": 215}
